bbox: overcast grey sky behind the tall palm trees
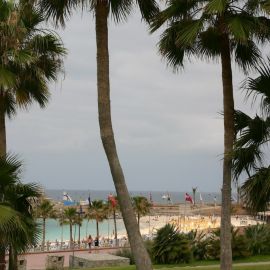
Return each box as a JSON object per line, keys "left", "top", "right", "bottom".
{"left": 7, "top": 9, "right": 254, "bottom": 192}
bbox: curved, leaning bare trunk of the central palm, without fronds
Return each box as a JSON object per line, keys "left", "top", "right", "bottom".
{"left": 95, "top": 1, "right": 152, "bottom": 270}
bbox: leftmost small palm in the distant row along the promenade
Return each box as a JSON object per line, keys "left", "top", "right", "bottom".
{"left": 37, "top": 199, "right": 56, "bottom": 250}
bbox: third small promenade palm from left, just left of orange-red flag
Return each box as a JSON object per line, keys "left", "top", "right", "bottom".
{"left": 87, "top": 200, "right": 108, "bottom": 242}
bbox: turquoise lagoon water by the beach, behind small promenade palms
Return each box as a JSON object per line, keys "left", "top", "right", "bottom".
{"left": 38, "top": 219, "right": 125, "bottom": 242}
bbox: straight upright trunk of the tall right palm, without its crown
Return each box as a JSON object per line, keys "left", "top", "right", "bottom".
{"left": 220, "top": 34, "right": 234, "bottom": 270}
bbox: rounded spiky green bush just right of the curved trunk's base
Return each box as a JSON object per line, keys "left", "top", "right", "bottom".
{"left": 152, "top": 224, "right": 192, "bottom": 264}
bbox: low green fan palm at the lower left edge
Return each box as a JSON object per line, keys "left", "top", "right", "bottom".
{"left": 0, "top": 156, "right": 41, "bottom": 270}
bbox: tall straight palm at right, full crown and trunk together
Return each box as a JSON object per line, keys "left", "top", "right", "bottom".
{"left": 152, "top": 0, "right": 270, "bottom": 270}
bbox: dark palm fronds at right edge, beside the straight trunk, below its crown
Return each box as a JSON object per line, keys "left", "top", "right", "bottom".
{"left": 233, "top": 58, "right": 270, "bottom": 213}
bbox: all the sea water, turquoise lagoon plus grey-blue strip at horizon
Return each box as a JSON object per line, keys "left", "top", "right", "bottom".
{"left": 40, "top": 189, "right": 224, "bottom": 242}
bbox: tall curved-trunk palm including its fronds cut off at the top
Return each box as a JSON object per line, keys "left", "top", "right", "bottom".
{"left": 37, "top": 0, "right": 158, "bottom": 270}
